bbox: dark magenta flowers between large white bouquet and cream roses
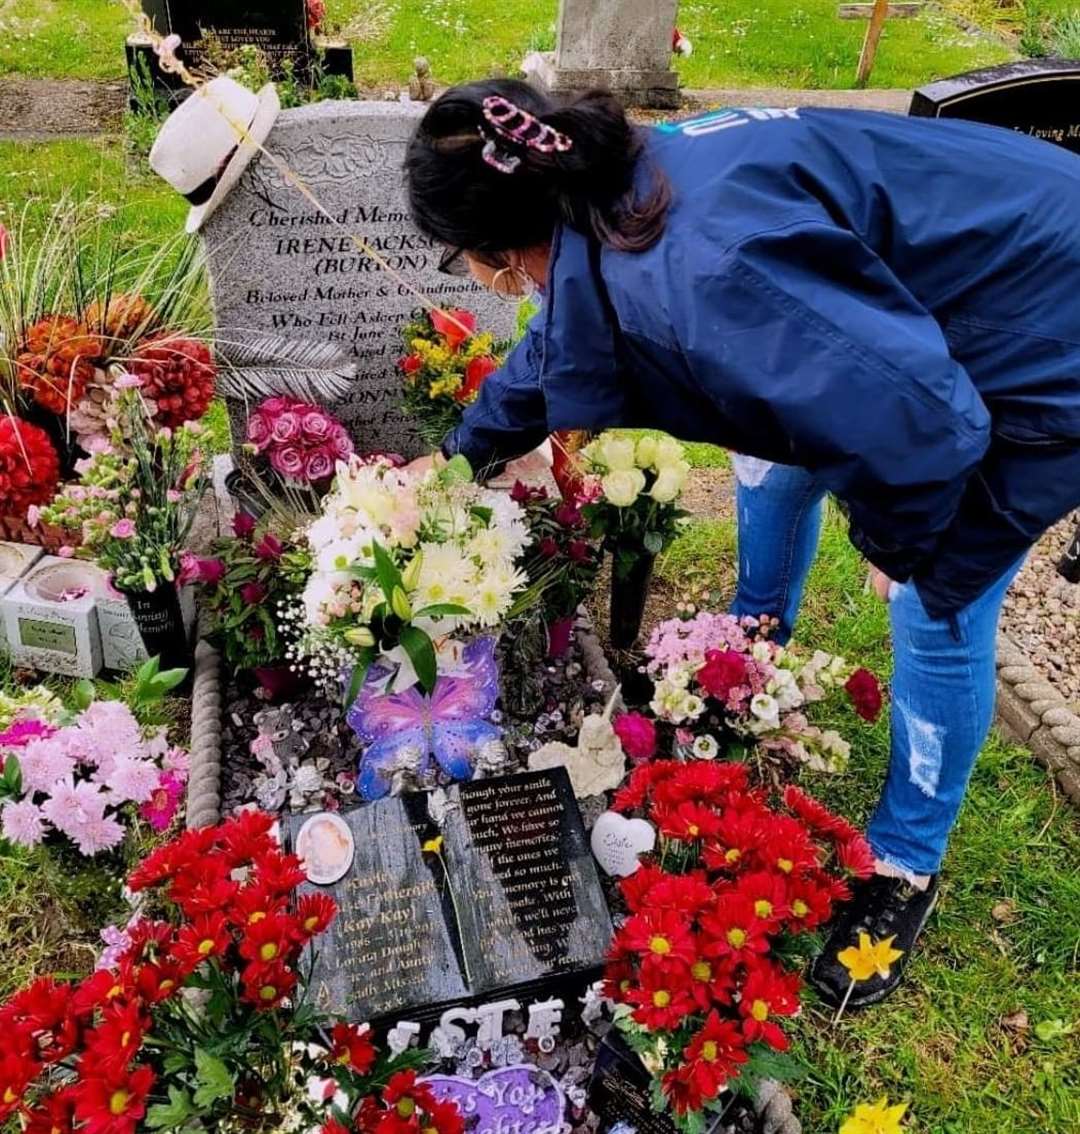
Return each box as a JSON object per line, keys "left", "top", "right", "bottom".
{"left": 511, "top": 481, "right": 600, "bottom": 658}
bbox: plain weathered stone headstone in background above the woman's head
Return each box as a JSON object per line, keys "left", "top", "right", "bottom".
{"left": 526, "top": 0, "right": 680, "bottom": 108}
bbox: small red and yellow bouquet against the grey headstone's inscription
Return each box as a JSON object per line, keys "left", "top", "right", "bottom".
{"left": 397, "top": 307, "right": 504, "bottom": 448}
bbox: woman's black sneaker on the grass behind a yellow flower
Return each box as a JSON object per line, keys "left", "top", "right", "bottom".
{"left": 809, "top": 874, "right": 937, "bottom": 1010}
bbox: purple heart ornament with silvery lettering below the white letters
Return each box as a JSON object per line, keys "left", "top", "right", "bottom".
{"left": 421, "top": 1064, "right": 569, "bottom": 1134}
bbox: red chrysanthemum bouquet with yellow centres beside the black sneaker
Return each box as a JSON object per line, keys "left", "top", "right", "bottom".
{"left": 606, "top": 761, "right": 874, "bottom": 1129}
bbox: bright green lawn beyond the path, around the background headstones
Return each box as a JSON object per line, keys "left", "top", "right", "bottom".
{"left": 0, "top": 0, "right": 1016, "bottom": 91}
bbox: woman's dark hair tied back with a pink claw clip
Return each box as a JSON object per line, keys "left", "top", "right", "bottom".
{"left": 405, "top": 78, "right": 670, "bottom": 261}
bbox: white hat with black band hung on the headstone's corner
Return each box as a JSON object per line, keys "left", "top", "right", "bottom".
{"left": 150, "top": 76, "right": 281, "bottom": 232}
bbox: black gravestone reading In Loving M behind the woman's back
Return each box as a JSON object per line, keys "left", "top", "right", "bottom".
{"left": 909, "top": 59, "right": 1080, "bottom": 153}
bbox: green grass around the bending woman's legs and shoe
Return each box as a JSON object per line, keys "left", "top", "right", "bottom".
{"left": 659, "top": 452, "right": 1080, "bottom": 1134}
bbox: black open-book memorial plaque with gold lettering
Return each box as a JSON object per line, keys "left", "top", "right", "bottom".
{"left": 287, "top": 768, "right": 611, "bottom": 1021}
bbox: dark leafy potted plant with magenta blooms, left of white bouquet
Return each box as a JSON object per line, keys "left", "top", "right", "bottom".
{"left": 190, "top": 511, "right": 310, "bottom": 671}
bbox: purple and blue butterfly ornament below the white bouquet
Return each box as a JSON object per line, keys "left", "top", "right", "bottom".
{"left": 346, "top": 637, "right": 503, "bottom": 799}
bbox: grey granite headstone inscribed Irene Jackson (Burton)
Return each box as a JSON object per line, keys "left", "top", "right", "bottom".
{"left": 203, "top": 102, "right": 516, "bottom": 457}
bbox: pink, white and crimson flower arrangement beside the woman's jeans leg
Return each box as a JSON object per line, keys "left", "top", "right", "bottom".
{"left": 644, "top": 611, "right": 883, "bottom": 771}
